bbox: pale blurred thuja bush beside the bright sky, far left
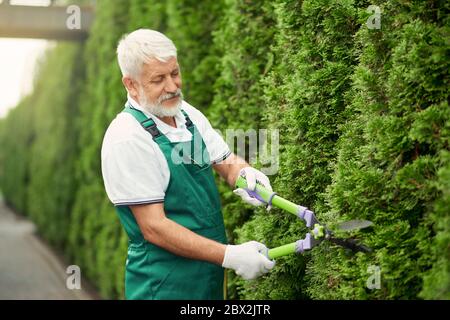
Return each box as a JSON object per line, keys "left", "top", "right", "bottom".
{"left": 21, "top": 43, "right": 84, "bottom": 248}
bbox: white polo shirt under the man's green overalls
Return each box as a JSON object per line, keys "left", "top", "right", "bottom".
{"left": 101, "top": 97, "right": 231, "bottom": 206}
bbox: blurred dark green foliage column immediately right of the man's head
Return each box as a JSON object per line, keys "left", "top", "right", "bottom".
{"left": 166, "top": 0, "right": 223, "bottom": 112}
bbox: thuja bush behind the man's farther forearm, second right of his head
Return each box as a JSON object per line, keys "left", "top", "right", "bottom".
{"left": 206, "top": 0, "right": 275, "bottom": 299}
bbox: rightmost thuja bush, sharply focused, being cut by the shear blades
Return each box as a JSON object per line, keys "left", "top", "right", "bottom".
{"left": 307, "top": 1, "right": 450, "bottom": 299}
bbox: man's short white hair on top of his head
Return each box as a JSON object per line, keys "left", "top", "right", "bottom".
{"left": 117, "top": 29, "right": 177, "bottom": 78}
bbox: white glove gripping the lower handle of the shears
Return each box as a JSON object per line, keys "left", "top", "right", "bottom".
{"left": 222, "top": 241, "right": 275, "bottom": 280}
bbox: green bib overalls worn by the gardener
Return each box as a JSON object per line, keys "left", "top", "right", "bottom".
{"left": 116, "top": 105, "right": 227, "bottom": 300}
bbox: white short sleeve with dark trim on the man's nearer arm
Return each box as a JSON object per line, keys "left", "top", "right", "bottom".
{"left": 102, "top": 139, "right": 165, "bottom": 206}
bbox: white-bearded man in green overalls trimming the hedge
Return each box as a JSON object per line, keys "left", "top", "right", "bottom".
{"left": 101, "top": 29, "right": 274, "bottom": 299}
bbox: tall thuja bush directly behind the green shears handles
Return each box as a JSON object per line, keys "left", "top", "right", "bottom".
{"left": 239, "top": 0, "right": 359, "bottom": 299}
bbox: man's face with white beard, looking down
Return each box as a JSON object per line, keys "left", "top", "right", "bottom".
{"left": 125, "top": 57, "right": 183, "bottom": 117}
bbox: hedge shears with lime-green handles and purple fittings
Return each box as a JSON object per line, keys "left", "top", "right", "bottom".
{"left": 236, "top": 175, "right": 372, "bottom": 260}
